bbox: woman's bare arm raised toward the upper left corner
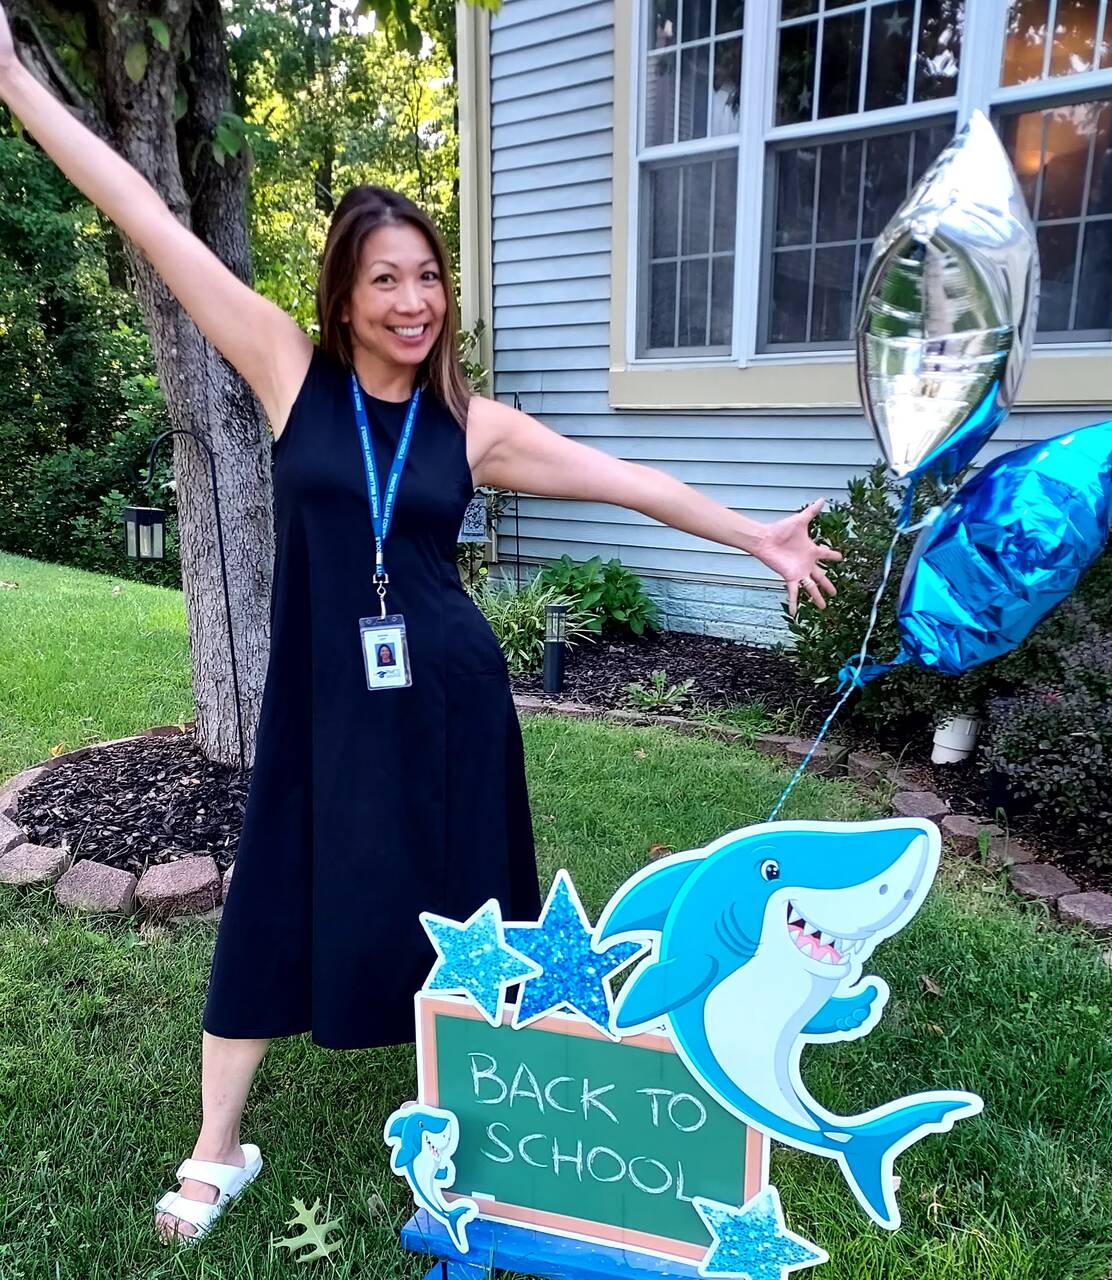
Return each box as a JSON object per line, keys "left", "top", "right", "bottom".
{"left": 0, "top": 4, "right": 312, "bottom": 431}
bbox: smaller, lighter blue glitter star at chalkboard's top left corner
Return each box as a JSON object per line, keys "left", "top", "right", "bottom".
{"left": 418, "top": 897, "right": 540, "bottom": 1027}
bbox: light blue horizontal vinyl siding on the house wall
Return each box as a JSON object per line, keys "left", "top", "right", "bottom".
{"left": 490, "top": 0, "right": 1103, "bottom": 639}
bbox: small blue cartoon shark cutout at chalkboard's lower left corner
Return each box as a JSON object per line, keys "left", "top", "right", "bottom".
{"left": 383, "top": 1102, "right": 479, "bottom": 1253}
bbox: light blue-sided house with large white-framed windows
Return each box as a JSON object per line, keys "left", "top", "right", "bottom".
{"left": 459, "top": 0, "right": 1112, "bottom": 643}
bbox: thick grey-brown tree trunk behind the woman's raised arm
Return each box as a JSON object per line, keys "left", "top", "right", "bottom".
{"left": 88, "top": 0, "right": 274, "bottom": 763}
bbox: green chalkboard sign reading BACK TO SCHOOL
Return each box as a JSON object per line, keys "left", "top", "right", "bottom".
{"left": 417, "top": 995, "right": 768, "bottom": 1260}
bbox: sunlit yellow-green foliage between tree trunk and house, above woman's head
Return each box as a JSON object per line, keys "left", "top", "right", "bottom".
{"left": 228, "top": 0, "right": 459, "bottom": 333}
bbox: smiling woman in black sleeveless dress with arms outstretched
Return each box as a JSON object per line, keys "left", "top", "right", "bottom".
{"left": 0, "top": 8, "right": 839, "bottom": 1239}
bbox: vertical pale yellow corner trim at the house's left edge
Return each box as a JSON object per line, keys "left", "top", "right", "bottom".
{"left": 456, "top": 0, "right": 494, "bottom": 384}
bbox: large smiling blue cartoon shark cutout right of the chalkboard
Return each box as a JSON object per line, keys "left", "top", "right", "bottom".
{"left": 595, "top": 818, "right": 983, "bottom": 1231}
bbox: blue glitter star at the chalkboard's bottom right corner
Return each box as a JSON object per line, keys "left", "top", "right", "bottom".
{"left": 691, "top": 1187, "right": 829, "bottom": 1280}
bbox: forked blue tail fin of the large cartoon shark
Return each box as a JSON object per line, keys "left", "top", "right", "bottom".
{"left": 838, "top": 1093, "right": 984, "bottom": 1231}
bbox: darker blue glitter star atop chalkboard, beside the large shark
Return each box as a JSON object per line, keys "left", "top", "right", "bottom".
{"left": 505, "top": 870, "right": 645, "bottom": 1038}
